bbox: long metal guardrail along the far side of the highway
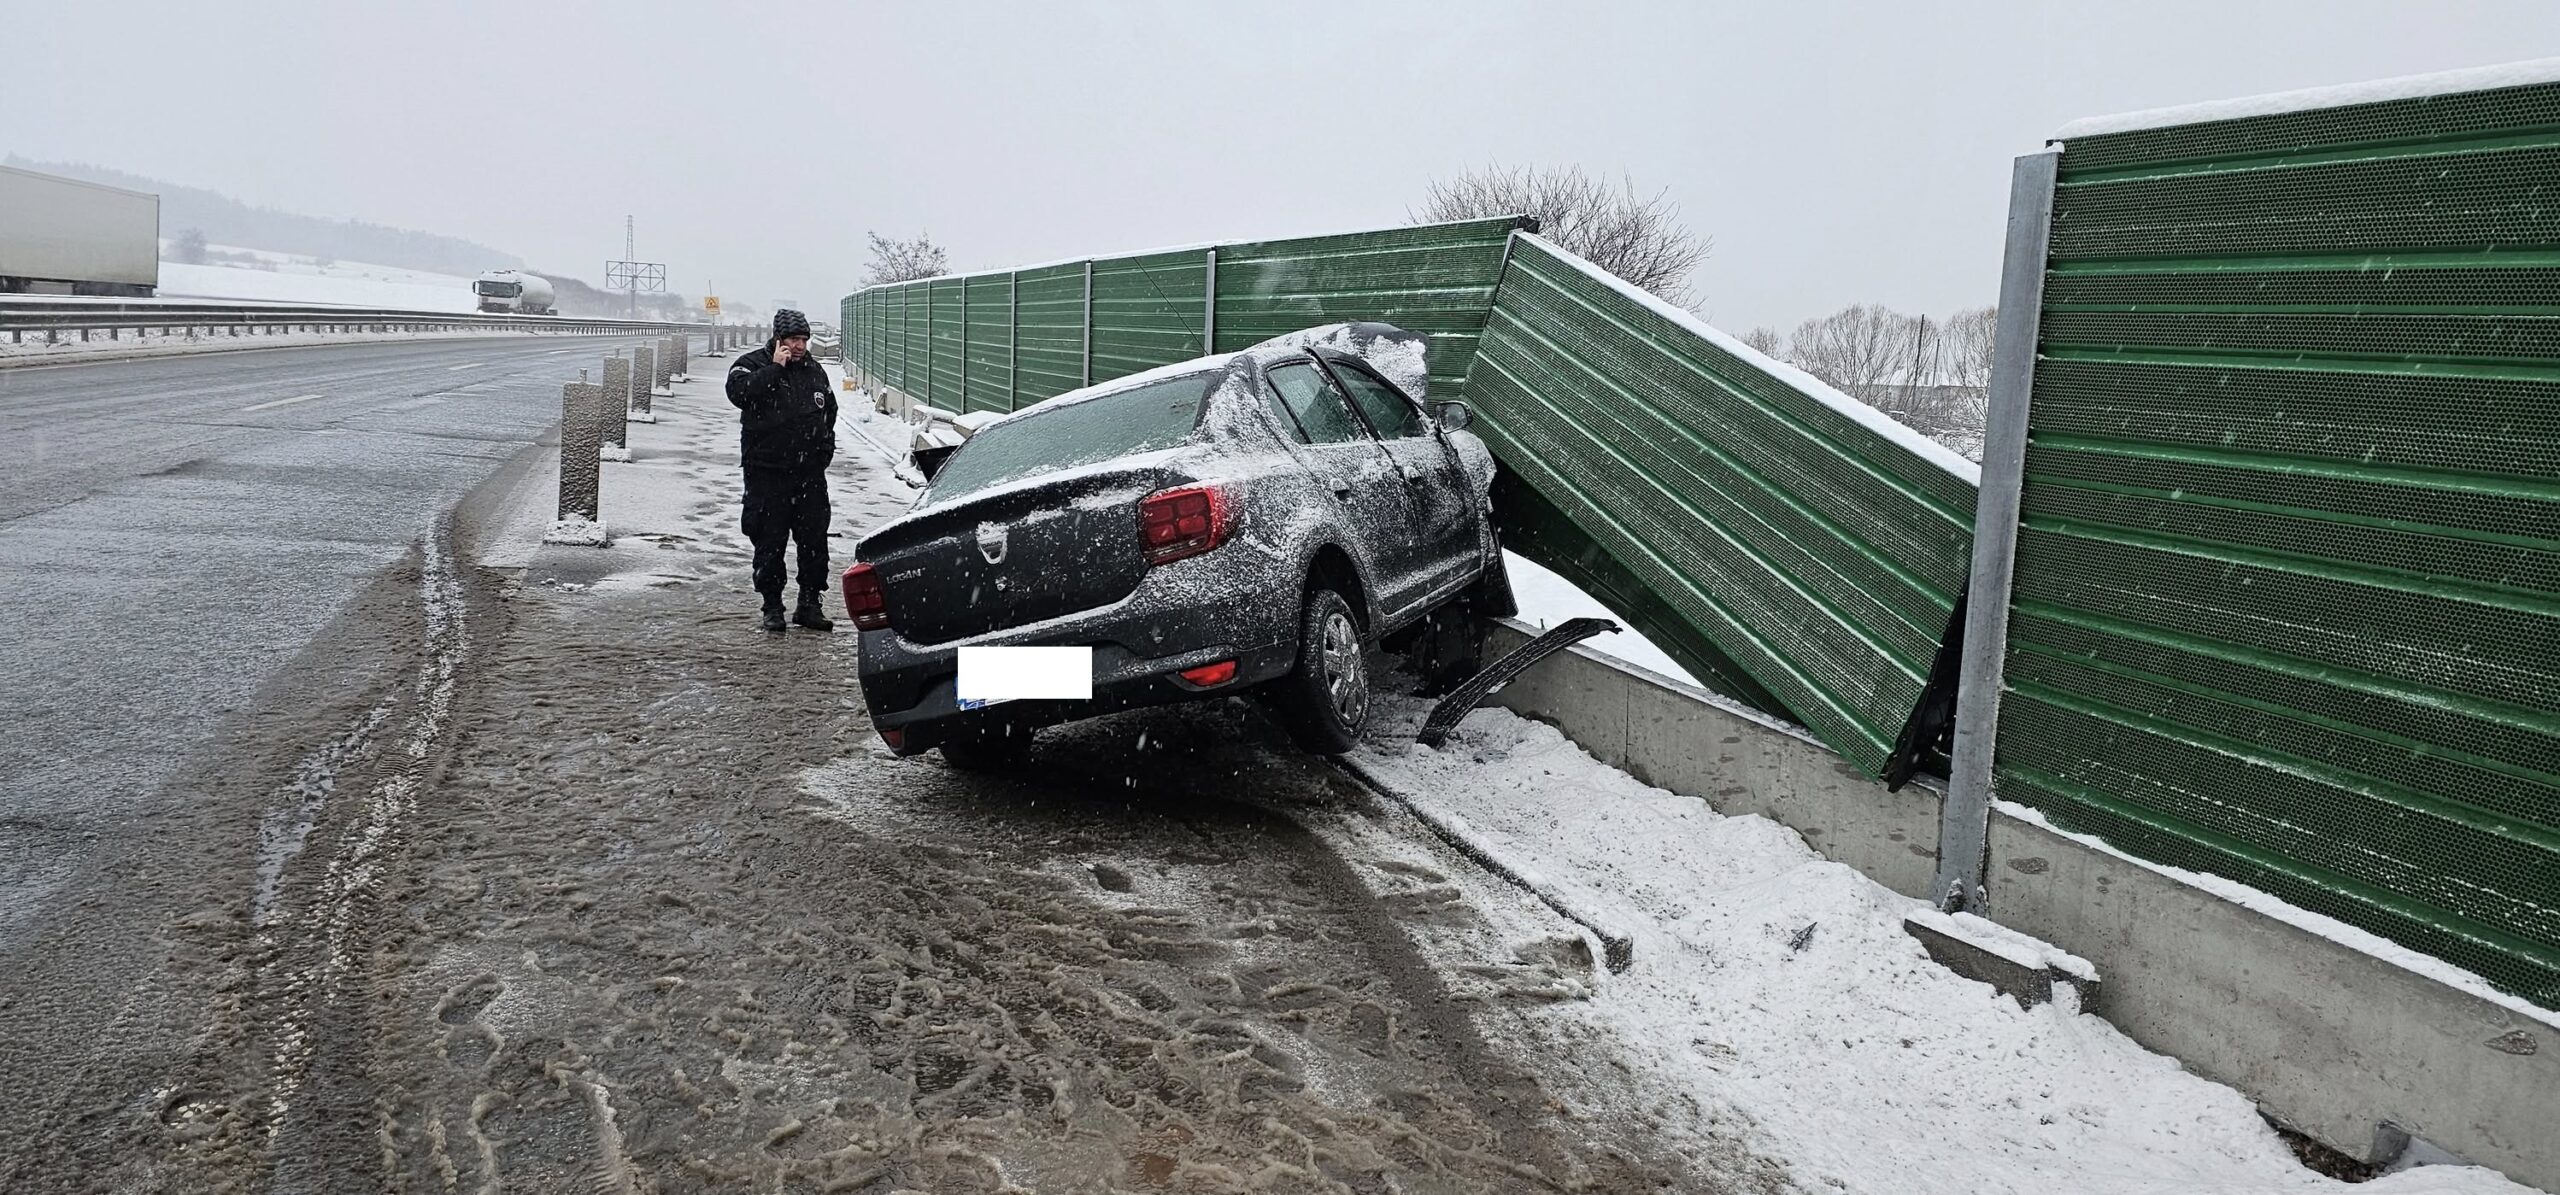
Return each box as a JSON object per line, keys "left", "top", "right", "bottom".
{"left": 0, "top": 299, "right": 714, "bottom": 343}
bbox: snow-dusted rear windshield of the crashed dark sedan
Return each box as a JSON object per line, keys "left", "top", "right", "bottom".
{"left": 927, "top": 371, "right": 1216, "bottom": 502}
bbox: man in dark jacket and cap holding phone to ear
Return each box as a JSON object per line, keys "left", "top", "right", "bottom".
{"left": 730, "top": 307, "right": 835, "bottom": 632}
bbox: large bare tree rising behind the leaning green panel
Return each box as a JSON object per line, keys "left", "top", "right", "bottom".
{"left": 1413, "top": 166, "right": 1713, "bottom": 305}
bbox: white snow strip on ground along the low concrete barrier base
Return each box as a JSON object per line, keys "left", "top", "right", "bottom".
{"left": 1331, "top": 699, "right": 2527, "bottom": 1195}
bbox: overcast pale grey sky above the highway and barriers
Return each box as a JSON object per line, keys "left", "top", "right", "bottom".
{"left": 0, "top": 0, "right": 2560, "bottom": 330}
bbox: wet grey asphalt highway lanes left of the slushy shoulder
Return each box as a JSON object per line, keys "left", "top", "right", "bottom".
{"left": 0, "top": 335, "right": 637, "bottom": 960}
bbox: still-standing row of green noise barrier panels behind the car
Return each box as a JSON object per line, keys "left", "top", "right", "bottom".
{"left": 842, "top": 218, "right": 1526, "bottom": 415}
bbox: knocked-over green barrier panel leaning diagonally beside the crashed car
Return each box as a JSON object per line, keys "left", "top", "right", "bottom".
{"left": 1467, "top": 235, "right": 1974, "bottom": 775}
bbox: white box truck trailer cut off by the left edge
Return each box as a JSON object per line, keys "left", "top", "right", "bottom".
{"left": 0, "top": 166, "right": 159, "bottom": 299}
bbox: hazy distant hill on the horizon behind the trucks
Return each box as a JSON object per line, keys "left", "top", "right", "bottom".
{"left": 8, "top": 154, "right": 525, "bottom": 279}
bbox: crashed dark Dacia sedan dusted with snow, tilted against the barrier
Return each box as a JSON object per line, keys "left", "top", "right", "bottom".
{"left": 845, "top": 325, "right": 1513, "bottom": 768}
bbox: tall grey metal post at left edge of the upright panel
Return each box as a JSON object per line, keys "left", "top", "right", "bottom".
{"left": 1930, "top": 151, "right": 2061, "bottom": 911}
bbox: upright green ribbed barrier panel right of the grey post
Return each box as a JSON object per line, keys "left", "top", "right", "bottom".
{"left": 1997, "top": 74, "right": 2560, "bottom": 1008}
